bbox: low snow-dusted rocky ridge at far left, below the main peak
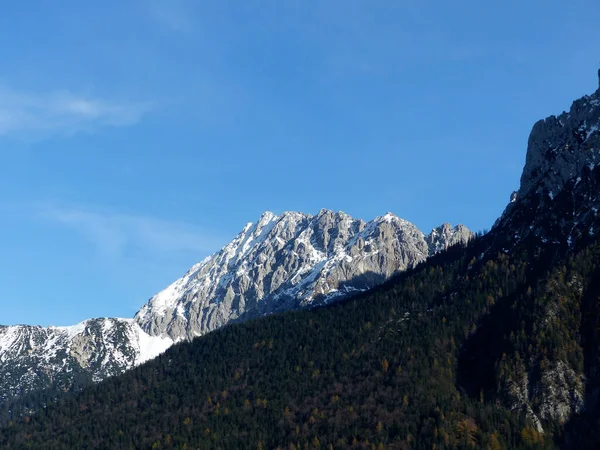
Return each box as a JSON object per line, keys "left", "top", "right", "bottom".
{"left": 0, "top": 319, "right": 172, "bottom": 401}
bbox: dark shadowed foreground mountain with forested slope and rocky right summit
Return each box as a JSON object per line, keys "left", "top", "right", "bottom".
{"left": 0, "top": 70, "right": 600, "bottom": 449}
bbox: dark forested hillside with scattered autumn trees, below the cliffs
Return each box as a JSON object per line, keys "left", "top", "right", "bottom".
{"left": 0, "top": 227, "right": 600, "bottom": 449}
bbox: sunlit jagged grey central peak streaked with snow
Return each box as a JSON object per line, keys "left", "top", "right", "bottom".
{"left": 135, "top": 210, "right": 472, "bottom": 340}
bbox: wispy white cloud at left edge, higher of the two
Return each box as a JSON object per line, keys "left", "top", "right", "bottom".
{"left": 0, "top": 84, "right": 151, "bottom": 136}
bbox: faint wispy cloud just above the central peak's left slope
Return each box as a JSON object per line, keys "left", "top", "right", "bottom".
{"left": 38, "top": 205, "right": 222, "bottom": 256}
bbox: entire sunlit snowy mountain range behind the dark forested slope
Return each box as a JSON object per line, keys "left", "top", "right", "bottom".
{"left": 0, "top": 210, "right": 472, "bottom": 401}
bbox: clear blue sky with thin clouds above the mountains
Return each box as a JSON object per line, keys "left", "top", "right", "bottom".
{"left": 0, "top": 0, "right": 600, "bottom": 325}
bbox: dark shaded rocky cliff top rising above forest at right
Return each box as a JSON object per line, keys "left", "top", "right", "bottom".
{"left": 495, "top": 75, "right": 600, "bottom": 247}
